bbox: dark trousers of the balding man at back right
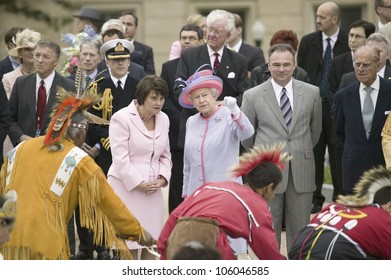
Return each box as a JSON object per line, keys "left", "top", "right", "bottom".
{"left": 312, "top": 99, "right": 338, "bottom": 206}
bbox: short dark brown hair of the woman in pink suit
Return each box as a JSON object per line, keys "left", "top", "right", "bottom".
{"left": 136, "top": 75, "right": 168, "bottom": 105}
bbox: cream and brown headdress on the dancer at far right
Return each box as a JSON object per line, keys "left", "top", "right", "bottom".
{"left": 337, "top": 166, "right": 391, "bottom": 206}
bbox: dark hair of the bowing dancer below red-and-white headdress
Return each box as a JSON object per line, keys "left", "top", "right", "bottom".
{"left": 246, "top": 161, "right": 282, "bottom": 191}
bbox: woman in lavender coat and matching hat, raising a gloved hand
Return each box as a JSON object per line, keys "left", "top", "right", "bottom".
{"left": 179, "top": 64, "right": 254, "bottom": 255}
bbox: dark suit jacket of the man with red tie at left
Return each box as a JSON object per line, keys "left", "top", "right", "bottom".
{"left": 9, "top": 72, "right": 75, "bottom": 146}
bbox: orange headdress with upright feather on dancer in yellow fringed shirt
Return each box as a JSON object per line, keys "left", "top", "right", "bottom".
{"left": 44, "top": 70, "right": 109, "bottom": 149}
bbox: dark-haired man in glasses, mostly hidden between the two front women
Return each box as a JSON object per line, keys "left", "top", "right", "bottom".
{"left": 160, "top": 24, "right": 204, "bottom": 213}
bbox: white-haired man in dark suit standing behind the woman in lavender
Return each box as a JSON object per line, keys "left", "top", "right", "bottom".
{"left": 174, "top": 10, "right": 249, "bottom": 147}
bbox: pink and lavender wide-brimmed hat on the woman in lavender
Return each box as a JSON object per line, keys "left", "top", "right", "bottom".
{"left": 179, "top": 64, "right": 223, "bottom": 109}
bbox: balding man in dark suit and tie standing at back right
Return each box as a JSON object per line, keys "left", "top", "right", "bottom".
{"left": 297, "top": 2, "right": 350, "bottom": 213}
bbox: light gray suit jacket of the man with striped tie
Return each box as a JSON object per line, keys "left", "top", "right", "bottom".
{"left": 242, "top": 79, "right": 322, "bottom": 194}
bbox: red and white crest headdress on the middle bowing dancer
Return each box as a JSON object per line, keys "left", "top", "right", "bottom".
{"left": 231, "top": 143, "right": 292, "bottom": 177}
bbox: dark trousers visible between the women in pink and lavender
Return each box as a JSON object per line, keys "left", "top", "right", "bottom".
{"left": 168, "top": 149, "right": 183, "bottom": 213}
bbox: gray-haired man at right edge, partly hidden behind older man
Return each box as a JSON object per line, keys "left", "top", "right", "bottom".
{"left": 339, "top": 32, "right": 391, "bottom": 89}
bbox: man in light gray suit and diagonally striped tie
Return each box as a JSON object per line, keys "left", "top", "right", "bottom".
{"left": 242, "top": 44, "right": 322, "bottom": 251}
